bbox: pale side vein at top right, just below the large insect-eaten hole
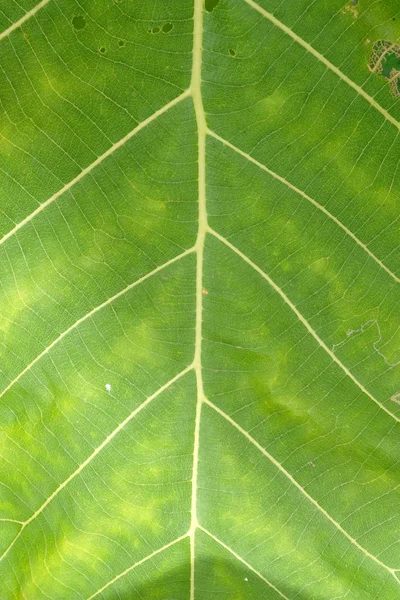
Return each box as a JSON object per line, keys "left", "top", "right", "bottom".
{"left": 244, "top": 0, "right": 400, "bottom": 131}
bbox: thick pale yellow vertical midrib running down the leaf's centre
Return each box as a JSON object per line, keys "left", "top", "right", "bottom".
{"left": 189, "top": 0, "right": 207, "bottom": 600}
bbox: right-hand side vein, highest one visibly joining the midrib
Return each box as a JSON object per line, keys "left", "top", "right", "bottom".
{"left": 207, "top": 129, "right": 400, "bottom": 283}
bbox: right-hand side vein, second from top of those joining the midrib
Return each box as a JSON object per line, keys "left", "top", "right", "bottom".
{"left": 209, "top": 228, "right": 400, "bottom": 423}
